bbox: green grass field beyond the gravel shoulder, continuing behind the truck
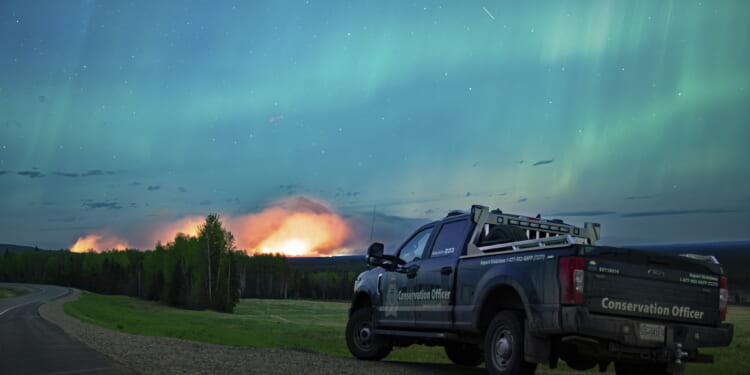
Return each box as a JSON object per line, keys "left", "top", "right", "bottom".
{"left": 65, "top": 292, "right": 750, "bottom": 375}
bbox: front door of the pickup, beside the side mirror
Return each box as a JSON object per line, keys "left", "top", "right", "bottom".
{"left": 377, "top": 226, "right": 434, "bottom": 328}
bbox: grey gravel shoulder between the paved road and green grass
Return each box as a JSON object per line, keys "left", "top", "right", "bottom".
{"left": 39, "top": 290, "right": 592, "bottom": 375}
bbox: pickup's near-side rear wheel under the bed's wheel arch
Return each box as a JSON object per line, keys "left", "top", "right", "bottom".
{"left": 484, "top": 311, "right": 536, "bottom": 375}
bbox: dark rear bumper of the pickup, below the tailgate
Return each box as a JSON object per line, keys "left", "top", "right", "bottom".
{"left": 561, "top": 306, "right": 734, "bottom": 351}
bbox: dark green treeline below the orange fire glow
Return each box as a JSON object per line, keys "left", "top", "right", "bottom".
{"left": 0, "top": 215, "right": 368, "bottom": 312}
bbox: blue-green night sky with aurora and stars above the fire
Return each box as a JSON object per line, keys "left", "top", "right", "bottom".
{"left": 0, "top": 0, "right": 750, "bottom": 253}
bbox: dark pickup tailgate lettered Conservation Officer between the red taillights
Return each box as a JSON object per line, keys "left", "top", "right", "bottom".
{"left": 584, "top": 249, "right": 720, "bottom": 325}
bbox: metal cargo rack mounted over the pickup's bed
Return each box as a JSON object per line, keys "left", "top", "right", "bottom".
{"left": 465, "top": 205, "right": 601, "bottom": 257}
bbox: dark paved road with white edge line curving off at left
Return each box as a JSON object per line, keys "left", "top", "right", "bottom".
{"left": 0, "top": 283, "right": 132, "bottom": 375}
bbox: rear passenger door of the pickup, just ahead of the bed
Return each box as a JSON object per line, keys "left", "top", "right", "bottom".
{"left": 414, "top": 219, "right": 471, "bottom": 328}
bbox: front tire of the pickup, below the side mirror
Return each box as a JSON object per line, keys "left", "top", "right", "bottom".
{"left": 346, "top": 308, "right": 393, "bottom": 361}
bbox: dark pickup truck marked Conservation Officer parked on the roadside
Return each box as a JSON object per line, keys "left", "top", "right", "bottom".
{"left": 346, "top": 205, "right": 733, "bottom": 375}
